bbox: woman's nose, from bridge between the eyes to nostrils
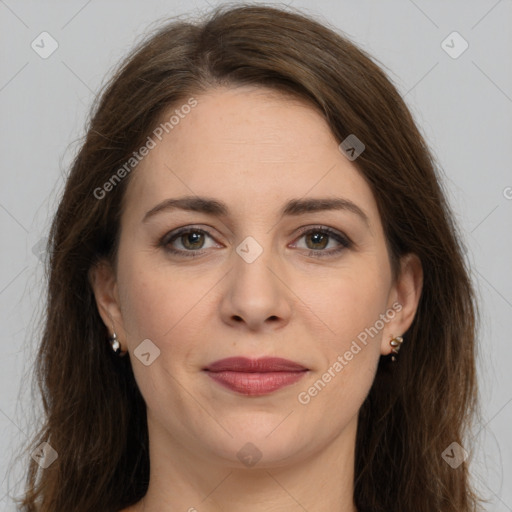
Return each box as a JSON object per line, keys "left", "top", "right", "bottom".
{"left": 220, "top": 239, "right": 293, "bottom": 331}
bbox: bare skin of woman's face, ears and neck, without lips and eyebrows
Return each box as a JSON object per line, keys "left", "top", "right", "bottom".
{"left": 92, "top": 86, "right": 422, "bottom": 512}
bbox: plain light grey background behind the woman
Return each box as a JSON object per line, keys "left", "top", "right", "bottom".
{"left": 0, "top": 0, "right": 512, "bottom": 512}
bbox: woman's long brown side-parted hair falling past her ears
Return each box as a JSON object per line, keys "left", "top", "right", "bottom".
{"left": 14, "top": 5, "right": 479, "bottom": 512}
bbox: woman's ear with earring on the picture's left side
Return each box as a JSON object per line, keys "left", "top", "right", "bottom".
{"left": 89, "top": 260, "right": 126, "bottom": 349}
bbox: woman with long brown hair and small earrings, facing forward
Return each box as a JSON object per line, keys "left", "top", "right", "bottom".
{"left": 15, "top": 6, "right": 479, "bottom": 512}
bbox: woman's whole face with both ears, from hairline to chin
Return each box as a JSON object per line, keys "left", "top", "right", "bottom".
{"left": 94, "top": 87, "right": 420, "bottom": 467}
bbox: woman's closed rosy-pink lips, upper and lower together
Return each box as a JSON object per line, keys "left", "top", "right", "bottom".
{"left": 204, "top": 357, "right": 308, "bottom": 396}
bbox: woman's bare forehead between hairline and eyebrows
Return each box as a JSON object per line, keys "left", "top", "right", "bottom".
{"left": 125, "top": 87, "right": 378, "bottom": 221}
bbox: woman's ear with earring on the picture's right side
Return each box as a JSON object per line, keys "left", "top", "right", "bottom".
{"left": 381, "top": 253, "right": 423, "bottom": 355}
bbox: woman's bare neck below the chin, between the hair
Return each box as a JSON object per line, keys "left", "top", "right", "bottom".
{"left": 129, "top": 416, "right": 357, "bottom": 512}
